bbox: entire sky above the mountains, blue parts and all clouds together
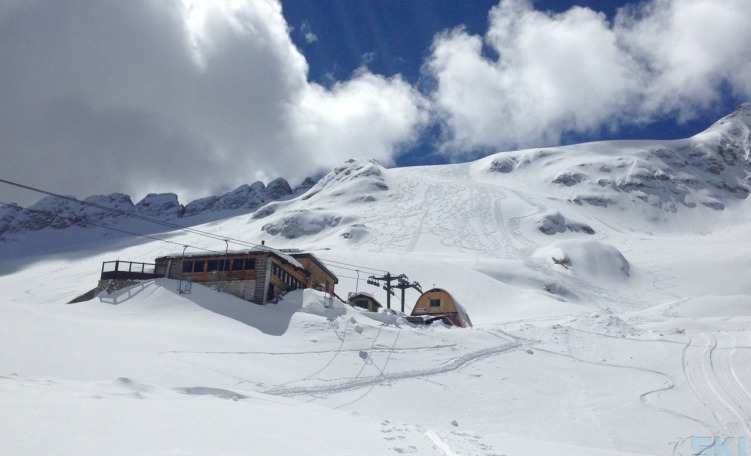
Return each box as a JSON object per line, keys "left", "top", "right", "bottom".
{"left": 0, "top": 0, "right": 751, "bottom": 204}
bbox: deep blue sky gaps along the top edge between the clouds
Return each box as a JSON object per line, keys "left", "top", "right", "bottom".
{"left": 282, "top": 0, "right": 628, "bottom": 84}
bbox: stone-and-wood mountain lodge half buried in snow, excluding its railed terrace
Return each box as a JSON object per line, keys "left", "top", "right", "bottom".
{"left": 156, "top": 248, "right": 339, "bottom": 304}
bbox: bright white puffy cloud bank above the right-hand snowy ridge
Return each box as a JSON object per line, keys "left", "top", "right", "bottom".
{"left": 426, "top": 0, "right": 751, "bottom": 155}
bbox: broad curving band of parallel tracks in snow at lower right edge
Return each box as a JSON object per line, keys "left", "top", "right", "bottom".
{"left": 683, "top": 333, "right": 751, "bottom": 436}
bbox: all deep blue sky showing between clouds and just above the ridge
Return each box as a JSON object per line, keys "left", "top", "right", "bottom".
{"left": 282, "top": 0, "right": 745, "bottom": 165}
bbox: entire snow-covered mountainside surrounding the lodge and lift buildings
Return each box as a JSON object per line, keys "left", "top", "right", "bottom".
{"left": 0, "top": 105, "right": 751, "bottom": 456}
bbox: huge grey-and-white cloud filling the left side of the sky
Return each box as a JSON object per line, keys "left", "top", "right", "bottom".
{"left": 0, "top": 0, "right": 424, "bottom": 203}
